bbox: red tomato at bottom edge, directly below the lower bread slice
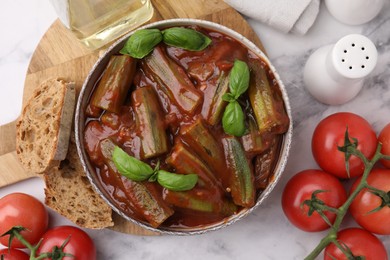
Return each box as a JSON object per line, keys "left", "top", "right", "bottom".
{"left": 37, "top": 226, "right": 96, "bottom": 260}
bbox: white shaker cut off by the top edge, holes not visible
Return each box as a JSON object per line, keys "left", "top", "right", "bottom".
{"left": 325, "top": 0, "right": 384, "bottom": 25}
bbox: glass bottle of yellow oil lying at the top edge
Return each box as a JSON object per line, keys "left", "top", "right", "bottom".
{"left": 51, "top": 0, "right": 153, "bottom": 49}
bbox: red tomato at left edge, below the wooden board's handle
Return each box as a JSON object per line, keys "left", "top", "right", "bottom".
{"left": 0, "top": 193, "right": 49, "bottom": 248}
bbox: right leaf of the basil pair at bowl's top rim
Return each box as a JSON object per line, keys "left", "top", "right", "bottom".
{"left": 162, "top": 27, "right": 211, "bottom": 51}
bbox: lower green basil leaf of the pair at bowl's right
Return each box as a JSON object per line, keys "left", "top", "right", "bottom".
{"left": 222, "top": 101, "right": 245, "bottom": 136}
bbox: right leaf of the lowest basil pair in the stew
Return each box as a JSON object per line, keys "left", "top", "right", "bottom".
{"left": 157, "top": 170, "right": 198, "bottom": 191}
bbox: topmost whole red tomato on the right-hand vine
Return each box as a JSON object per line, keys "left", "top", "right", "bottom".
{"left": 312, "top": 112, "right": 377, "bottom": 178}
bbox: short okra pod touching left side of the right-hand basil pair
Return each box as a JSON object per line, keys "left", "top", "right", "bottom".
{"left": 202, "top": 71, "right": 229, "bottom": 125}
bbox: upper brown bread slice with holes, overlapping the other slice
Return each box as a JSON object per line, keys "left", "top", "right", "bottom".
{"left": 16, "top": 79, "right": 76, "bottom": 173}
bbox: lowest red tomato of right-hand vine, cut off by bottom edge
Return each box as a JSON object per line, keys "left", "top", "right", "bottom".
{"left": 324, "top": 228, "right": 387, "bottom": 260}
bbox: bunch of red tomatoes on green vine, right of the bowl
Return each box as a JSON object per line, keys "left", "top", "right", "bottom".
{"left": 282, "top": 112, "right": 390, "bottom": 260}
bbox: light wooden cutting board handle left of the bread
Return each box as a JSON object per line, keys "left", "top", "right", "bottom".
{"left": 0, "top": 120, "right": 36, "bottom": 187}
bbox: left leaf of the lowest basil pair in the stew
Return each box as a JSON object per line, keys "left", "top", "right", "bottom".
{"left": 112, "top": 146, "right": 154, "bottom": 181}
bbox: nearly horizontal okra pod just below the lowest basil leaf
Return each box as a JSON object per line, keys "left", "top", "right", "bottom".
{"left": 164, "top": 190, "right": 237, "bottom": 216}
